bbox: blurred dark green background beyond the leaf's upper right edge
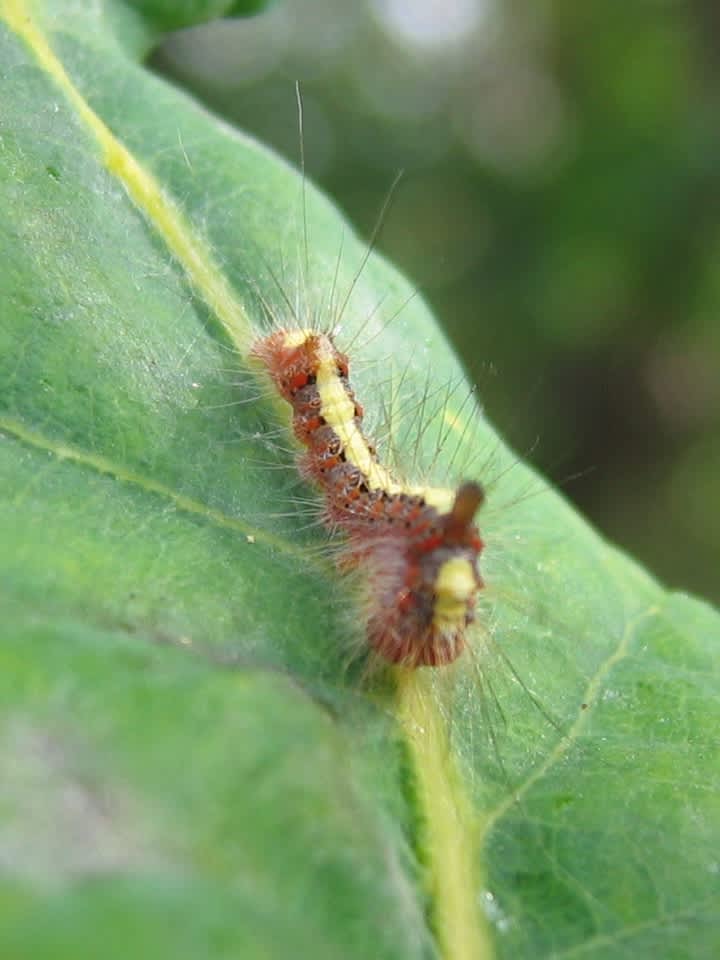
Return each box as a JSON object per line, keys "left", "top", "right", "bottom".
{"left": 153, "top": 0, "right": 720, "bottom": 602}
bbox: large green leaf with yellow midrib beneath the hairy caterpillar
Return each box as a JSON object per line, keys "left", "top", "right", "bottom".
{"left": 0, "top": 0, "right": 720, "bottom": 960}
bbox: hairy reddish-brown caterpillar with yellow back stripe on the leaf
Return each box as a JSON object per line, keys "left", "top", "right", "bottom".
{"left": 251, "top": 330, "right": 484, "bottom": 667}
